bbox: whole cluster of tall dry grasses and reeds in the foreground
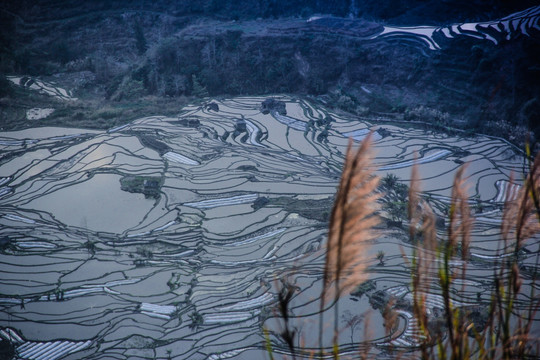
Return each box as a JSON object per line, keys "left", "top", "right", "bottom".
{"left": 264, "top": 137, "right": 540, "bottom": 360}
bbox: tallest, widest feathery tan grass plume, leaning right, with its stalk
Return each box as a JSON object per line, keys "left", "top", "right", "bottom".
{"left": 319, "top": 133, "right": 379, "bottom": 359}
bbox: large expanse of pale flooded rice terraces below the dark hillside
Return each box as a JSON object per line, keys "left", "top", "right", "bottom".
{"left": 0, "top": 97, "right": 540, "bottom": 359}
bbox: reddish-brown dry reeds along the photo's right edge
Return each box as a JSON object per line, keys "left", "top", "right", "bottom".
{"left": 476, "top": 150, "right": 540, "bottom": 359}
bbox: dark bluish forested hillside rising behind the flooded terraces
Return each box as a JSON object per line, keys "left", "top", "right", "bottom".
{"left": 0, "top": 0, "right": 540, "bottom": 146}
